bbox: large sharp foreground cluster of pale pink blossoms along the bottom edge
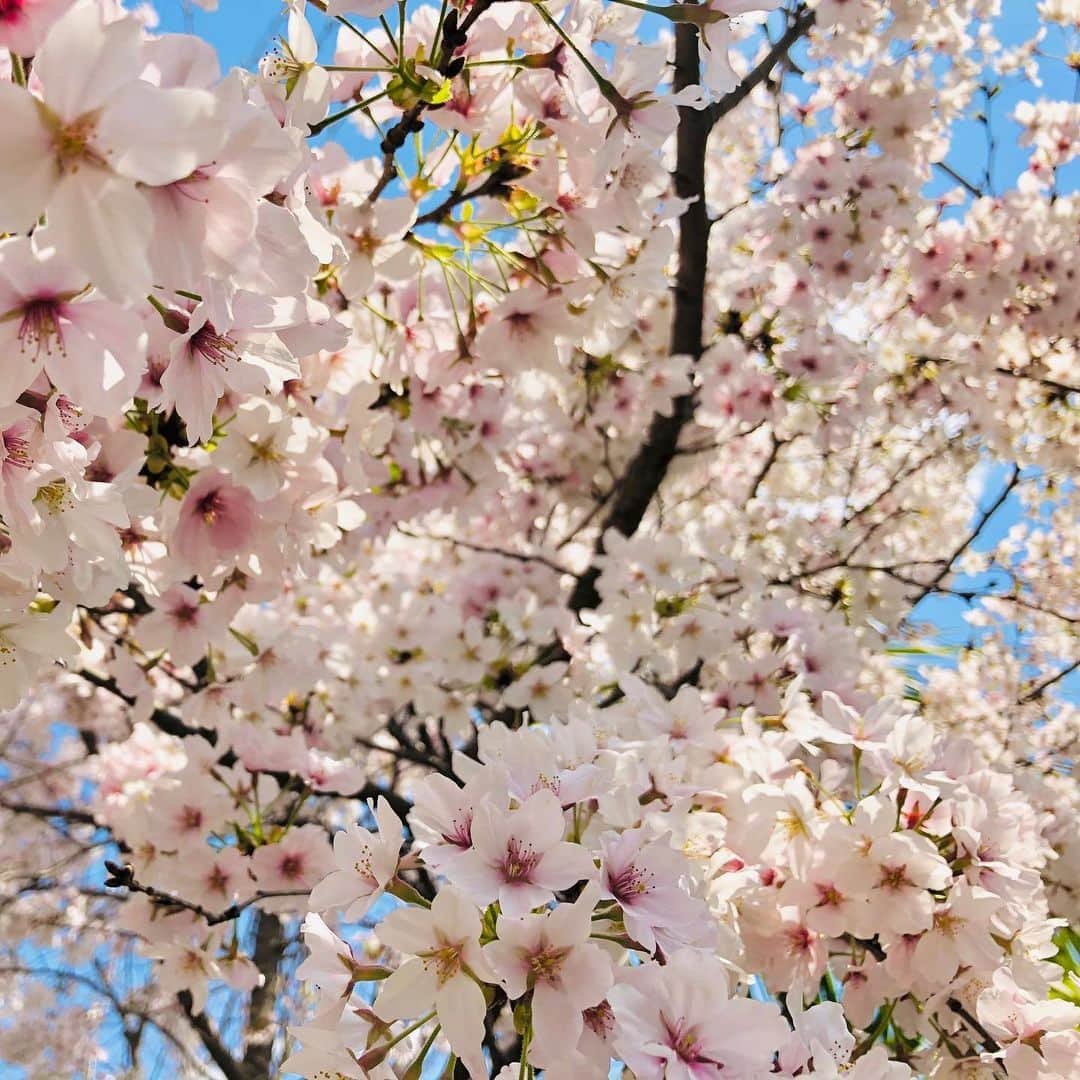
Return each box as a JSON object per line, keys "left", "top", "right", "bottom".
{"left": 270, "top": 676, "right": 1080, "bottom": 1080}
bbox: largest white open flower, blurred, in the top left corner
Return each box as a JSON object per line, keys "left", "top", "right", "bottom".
{"left": 0, "top": 0, "right": 222, "bottom": 299}
